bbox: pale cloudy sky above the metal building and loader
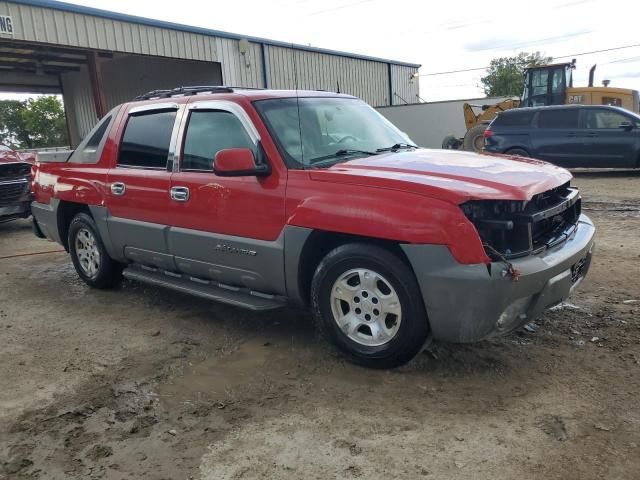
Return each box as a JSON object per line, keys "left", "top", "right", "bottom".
{"left": 5, "top": 0, "right": 640, "bottom": 101}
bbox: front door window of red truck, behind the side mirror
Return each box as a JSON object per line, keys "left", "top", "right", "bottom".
{"left": 181, "top": 110, "right": 256, "bottom": 171}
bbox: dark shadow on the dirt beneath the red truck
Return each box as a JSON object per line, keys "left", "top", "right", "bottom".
{"left": 121, "top": 281, "right": 534, "bottom": 384}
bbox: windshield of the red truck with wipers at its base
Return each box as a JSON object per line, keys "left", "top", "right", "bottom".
{"left": 255, "top": 97, "right": 413, "bottom": 168}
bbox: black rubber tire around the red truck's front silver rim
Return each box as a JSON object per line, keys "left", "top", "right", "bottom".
{"left": 311, "top": 244, "right": 429, "bottom": 368}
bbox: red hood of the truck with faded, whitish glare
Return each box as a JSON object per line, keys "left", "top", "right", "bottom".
{"left": 310, "top": 149, "right": 571, "bottom": 204}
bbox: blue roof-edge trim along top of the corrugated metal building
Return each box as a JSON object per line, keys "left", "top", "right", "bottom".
{"left": 7, "top": 0, "right": 421, "bottom": 68}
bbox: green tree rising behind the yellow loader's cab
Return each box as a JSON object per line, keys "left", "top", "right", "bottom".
{"left": 480, "top": 52, "right": 553, "bottom": 97}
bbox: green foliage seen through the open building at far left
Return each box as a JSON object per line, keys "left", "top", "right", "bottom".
{"left": 0, "top": 96, "right": 69, "bottom": 149}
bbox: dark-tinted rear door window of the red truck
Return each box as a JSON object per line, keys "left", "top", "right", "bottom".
{"left": 118, "top": 110, "right": 176, "bottom": 169}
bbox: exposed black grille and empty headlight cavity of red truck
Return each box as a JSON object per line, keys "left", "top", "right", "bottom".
{"left": 461, "top": 182, "right": 581, "bottom": 262}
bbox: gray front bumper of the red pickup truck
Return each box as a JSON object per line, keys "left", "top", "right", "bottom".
{"left": 402, "top": 215, "right": 596, "bottom": 342}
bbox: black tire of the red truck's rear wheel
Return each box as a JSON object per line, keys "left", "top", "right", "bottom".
{"left": 68, "top": 213, "right": 122, "bottom": 289}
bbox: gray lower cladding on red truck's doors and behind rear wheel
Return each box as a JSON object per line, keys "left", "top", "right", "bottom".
{"left": 32, "top": 199, "right": 311, "bottom": 301}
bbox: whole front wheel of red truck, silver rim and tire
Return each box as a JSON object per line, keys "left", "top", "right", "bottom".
{"left": 311, "top": 244, "right": 429, "bottom": 368}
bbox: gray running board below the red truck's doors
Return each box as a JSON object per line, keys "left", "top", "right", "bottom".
{"left": 122, "top": 265, "right": 287, "bottom": 310}
